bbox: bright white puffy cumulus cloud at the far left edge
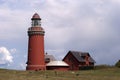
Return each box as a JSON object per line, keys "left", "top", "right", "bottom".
{"left": 0, "top": 47, "right": 13, "bottom": 64}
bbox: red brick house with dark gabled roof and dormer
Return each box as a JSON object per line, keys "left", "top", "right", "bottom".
{"left": 63, "top": 51, "right": 95, "bottom": 70}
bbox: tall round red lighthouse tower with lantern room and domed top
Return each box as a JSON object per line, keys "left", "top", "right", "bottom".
{"left": 26, "top": 13, "right": 46, "bottom": 70}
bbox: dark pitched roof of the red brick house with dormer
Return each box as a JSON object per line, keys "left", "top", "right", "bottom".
{"left": 68, "top": 51, "right": 95, "bottom": 62}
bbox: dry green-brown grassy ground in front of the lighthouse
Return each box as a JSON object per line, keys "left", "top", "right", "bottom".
{"left": 0, "top": 68, "right": 120, "bottom": 80}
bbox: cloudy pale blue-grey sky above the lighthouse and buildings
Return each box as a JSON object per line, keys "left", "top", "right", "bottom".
{"left": 0, "top": 0, "right": 120, "bottom": 70}
